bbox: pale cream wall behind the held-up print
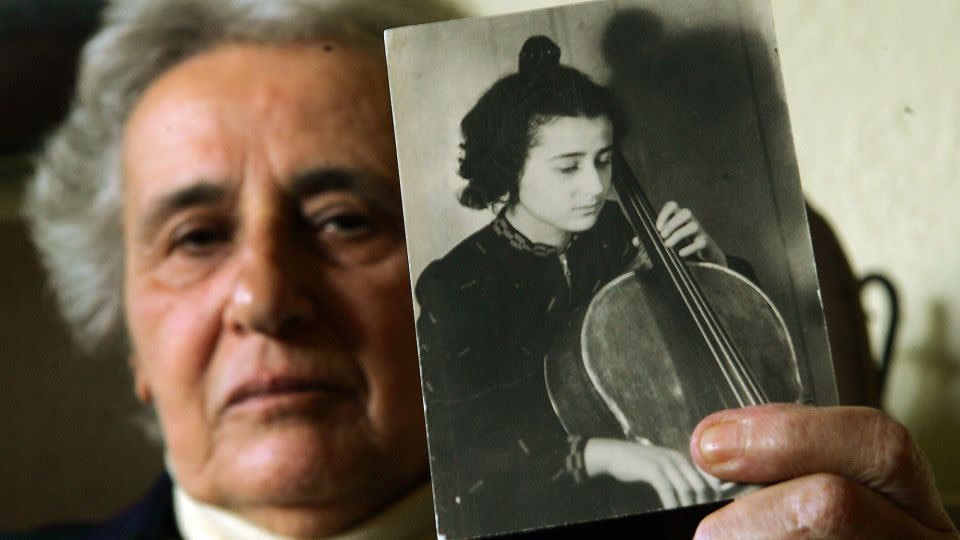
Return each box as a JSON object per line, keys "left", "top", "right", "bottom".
{"left": 459, "top": 0, "right": 960, "bottom": 502}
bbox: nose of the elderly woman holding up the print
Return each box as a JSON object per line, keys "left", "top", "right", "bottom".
{"left": 224, "top": 230, "right": 315, "bottom": 339}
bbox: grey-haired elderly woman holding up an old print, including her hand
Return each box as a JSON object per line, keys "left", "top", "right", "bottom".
{"left": 16, "top": 0, "right": 956, "bottom": 539}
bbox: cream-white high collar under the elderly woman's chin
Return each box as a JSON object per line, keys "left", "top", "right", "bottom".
{"left": 173, "top": 482, "right": 435, "bottom": 540}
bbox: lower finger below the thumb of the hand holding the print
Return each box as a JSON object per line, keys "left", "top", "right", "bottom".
{"left": 694, "top": 474, "right": 952, "bottom": 540}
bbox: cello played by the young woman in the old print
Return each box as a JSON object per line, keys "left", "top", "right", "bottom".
{"left": 544, "top": 155, "right": 801, "bottom": 476}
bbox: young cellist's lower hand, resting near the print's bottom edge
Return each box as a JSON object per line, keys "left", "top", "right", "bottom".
{"left": 583, "top": 438, "right": 716, "bottom": 508}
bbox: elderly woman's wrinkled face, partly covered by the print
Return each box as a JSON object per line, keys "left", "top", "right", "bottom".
{"left": 123, "top": 43, "right": 427, "bottom": 532}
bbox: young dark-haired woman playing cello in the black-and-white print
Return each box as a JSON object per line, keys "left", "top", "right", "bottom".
{"left": 416, "top": 36, "right": 744, "bottom": 532}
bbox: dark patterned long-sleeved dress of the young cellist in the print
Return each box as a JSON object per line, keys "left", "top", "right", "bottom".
{"left": 416, "top": 203, "right": 656, "bottom": 536}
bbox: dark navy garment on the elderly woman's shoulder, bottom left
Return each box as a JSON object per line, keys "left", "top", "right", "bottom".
{"left": 0, "top": 473, "right": 181, "bottom": 540}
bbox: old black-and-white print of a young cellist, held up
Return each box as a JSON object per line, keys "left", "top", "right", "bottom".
{"left": 386, "top": 0, "right": 836, "bottom": 538}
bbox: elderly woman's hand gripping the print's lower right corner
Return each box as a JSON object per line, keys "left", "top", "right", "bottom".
{"left": 690, "top": 405, "right": 960, "bottom": 540}
